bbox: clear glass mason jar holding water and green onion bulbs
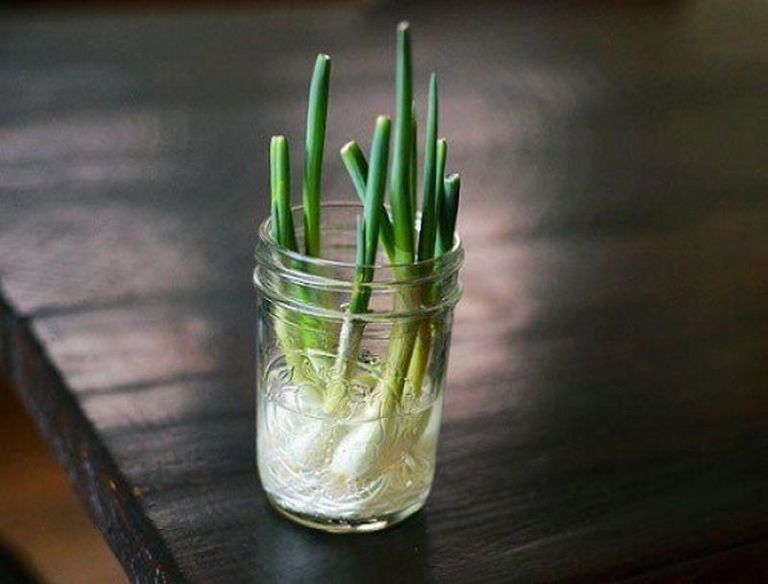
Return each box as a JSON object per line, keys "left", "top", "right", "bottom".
{"left": 254, "top": 203, "right": 463, "bottom": 532}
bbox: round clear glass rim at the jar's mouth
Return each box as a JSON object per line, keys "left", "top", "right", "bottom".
{"left": 258, "top": 200, "right": 463, "bottom": 270}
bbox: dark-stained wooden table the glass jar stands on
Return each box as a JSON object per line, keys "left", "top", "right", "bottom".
{"left": 0, "top": 2, "right": 768, "bottom": 582}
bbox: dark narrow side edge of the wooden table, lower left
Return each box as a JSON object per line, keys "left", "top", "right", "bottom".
{"left": 0, "top": 289, "right": 183, "bottom": 582}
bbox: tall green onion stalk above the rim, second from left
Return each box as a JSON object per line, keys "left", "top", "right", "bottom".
{"left": 302, "top": 55, "right": 331, "bottom": 256}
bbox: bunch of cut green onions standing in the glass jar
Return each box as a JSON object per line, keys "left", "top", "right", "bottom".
{"left": 270, "top": 23, "right": 460, "bottom": 475}
